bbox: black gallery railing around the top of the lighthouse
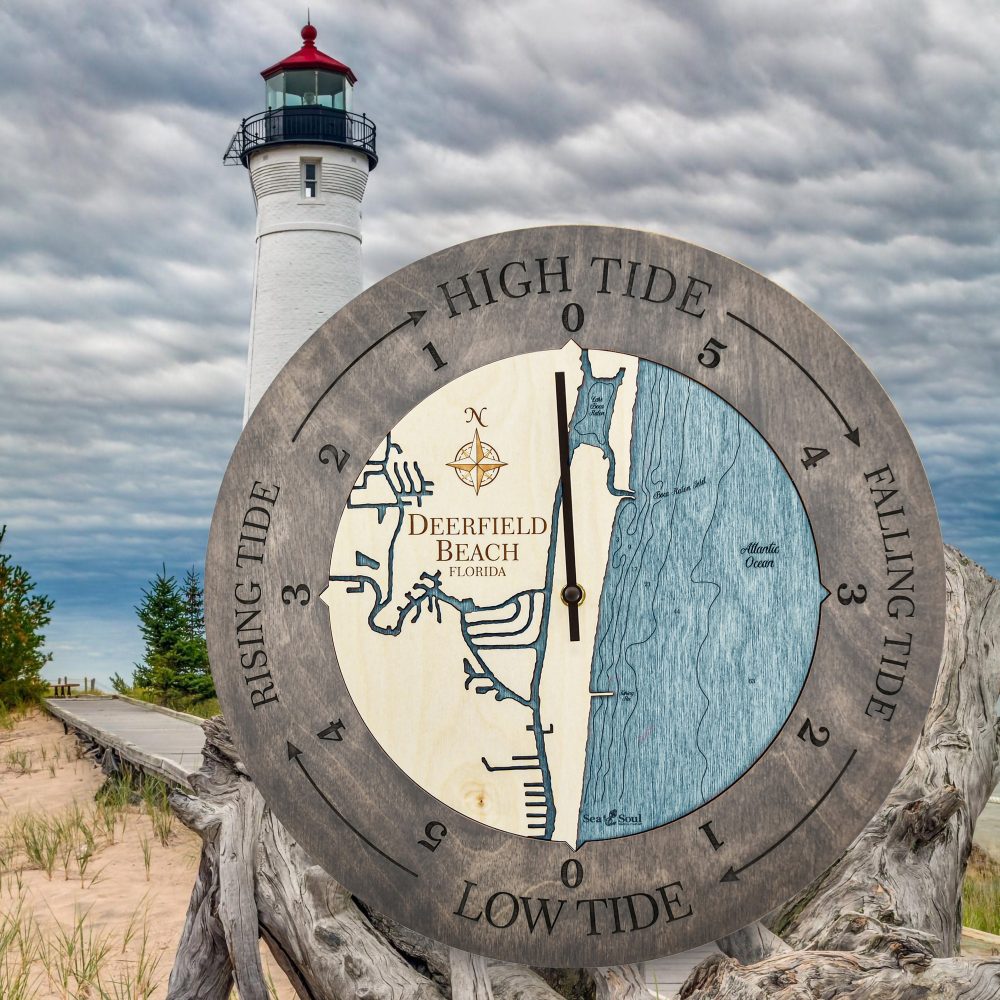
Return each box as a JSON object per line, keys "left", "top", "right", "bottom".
{"left": 223, "top": 107, "right": 378, "bottom": 169}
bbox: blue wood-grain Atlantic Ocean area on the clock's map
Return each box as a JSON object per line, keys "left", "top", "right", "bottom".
{"left": 578, "top": 361, "right": 826, "bottom": 843}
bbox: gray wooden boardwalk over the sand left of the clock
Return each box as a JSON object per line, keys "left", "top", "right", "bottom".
{"left": 45, "top": 697, "right": 205, "bottom": 788}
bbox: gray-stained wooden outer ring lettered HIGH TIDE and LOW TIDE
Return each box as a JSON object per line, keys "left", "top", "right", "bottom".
{"left": 206, "top": 226, "right": 945, "bottom": 966}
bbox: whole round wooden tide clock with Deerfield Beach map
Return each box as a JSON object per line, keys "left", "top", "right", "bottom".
{"left": 206, "top": 227, "right": 944, "bottom": 966}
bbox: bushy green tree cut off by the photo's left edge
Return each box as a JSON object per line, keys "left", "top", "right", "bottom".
{"left": 0, "top": 525, "right": 54, "bottom": 708}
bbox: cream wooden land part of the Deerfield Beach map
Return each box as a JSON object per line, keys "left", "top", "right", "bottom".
{"left": 323, "top": 343, "right": 637, "bottom": 843}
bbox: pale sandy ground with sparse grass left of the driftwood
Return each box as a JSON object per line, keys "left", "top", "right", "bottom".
{"left": 0, "top": 713, "right": 296, "bottom": 1000}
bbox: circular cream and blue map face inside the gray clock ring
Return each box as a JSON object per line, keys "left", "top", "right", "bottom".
{"left": 323, "top": 342, "right": 827, "bottom": 847}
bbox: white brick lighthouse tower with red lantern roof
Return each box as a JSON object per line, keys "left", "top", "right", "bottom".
{"left": 224, "top": 24, "right": 378, "bottom": 422}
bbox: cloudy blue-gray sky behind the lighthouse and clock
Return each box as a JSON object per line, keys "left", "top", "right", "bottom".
{"left": 0, "top": 0, "right": 1000, "bottom": 679}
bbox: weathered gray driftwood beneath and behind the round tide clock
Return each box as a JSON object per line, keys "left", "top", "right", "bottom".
{"left": 168, "top": 549, "right": 1000, "bottom": 1000}
